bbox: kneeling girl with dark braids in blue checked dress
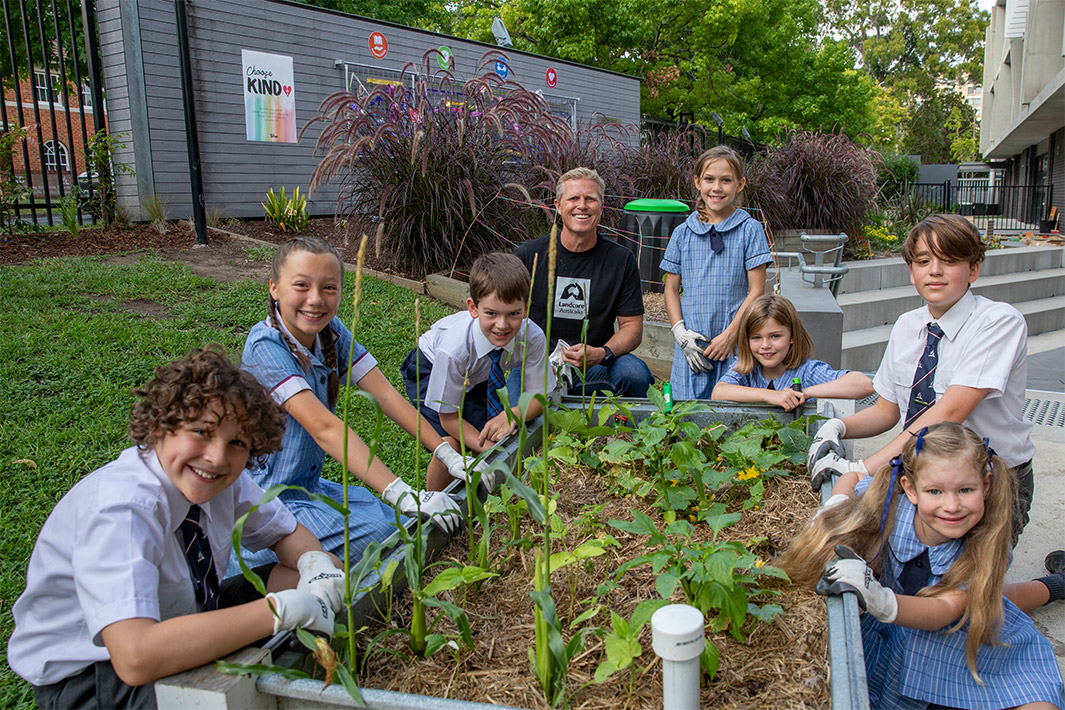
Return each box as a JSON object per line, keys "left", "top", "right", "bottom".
{"left": 229, "top": 237, "right": 469, "bottom": 574}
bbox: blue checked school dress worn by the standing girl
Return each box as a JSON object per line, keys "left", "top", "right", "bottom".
{"left": 660, "top": 210, "right": 773, "bottom": 399}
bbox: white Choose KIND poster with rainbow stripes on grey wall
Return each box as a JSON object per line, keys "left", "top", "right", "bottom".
{"left": 241, "top": 49, "right": 296, "bottom": 143}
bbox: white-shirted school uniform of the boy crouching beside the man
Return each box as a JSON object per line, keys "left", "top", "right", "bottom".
{"left": 402, "top": 311, "right": 555, "bottom": 436}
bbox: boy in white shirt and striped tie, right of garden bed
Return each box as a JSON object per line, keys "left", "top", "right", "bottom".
{"left": 807, "top": 214, "right": 1035, "bottom": 544}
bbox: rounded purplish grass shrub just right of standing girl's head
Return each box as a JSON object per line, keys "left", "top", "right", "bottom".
{"left": 748, "top": 131, "right": 879, "bottom": 242}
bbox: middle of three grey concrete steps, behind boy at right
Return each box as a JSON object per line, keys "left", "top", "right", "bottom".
{"left": 837, "top": 267, "right": 1065, "bottom": 333}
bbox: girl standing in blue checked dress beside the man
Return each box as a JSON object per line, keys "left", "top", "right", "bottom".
{"left": 661, "top": 146, "right": 773, "bottom": 399}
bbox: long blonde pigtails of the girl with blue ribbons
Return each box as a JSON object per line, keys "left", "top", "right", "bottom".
{"left": 780, "top": 422, "right": 1015, "bottom": 684}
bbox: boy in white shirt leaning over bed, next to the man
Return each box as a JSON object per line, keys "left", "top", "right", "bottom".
{"left": 403, "top": 252, "right": 555, "bottom": 490}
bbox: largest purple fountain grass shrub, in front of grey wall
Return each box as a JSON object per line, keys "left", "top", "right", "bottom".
{"left": 304, "top": 50, "right": 573, "bottom": 277}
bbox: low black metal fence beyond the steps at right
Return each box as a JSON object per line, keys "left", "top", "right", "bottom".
{"left": 881, "top": 178, "right": 1056, "bottom": 232}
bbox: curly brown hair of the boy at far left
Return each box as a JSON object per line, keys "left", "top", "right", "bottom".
{"left": 129, "top": 345, "right": 284, "bottom": 464}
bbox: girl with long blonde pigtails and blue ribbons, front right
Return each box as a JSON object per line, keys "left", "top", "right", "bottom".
{"left": 782, "top": 422, "right": 1065, "bottom": 709}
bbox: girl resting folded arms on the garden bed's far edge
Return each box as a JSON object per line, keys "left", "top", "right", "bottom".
{"left": 712, "top": 294, "right": 872, "bottom": 412}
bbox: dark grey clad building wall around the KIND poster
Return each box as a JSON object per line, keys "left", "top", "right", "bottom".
{"left": 97, "top": 0, "right": 640, "bottom": 218}
